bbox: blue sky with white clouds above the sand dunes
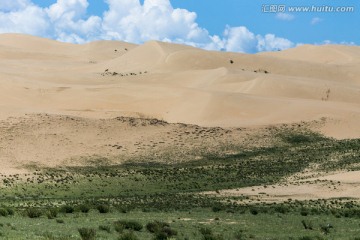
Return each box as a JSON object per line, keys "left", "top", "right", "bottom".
{"left": 0, "top": 0, "right": 360, "bottom": 53}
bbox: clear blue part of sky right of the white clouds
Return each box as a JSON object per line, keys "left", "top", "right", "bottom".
{"left": 172, "top": 0, "right": 360, "bottom": 45}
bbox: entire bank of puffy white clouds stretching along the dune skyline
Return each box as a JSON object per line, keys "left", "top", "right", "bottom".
{"left": 0, "top": 0, "right": 293, "bottom": 53}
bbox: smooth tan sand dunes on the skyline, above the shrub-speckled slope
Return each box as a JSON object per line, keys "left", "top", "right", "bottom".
{"left": 0, "top": 34, "right": 360, "bottom": 138}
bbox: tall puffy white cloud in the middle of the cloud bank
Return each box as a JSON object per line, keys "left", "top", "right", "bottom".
{"left": 103, "top": 0, "right": 210, "bottom": 44}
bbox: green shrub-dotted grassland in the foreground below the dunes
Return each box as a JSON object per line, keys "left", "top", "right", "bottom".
{"left": 0, "top": 128, "right": 360, "bottom": 239}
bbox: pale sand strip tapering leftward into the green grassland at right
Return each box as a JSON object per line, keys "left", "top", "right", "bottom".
{"left": 204, "top": 171, "right": 360, "bottom": 203}
